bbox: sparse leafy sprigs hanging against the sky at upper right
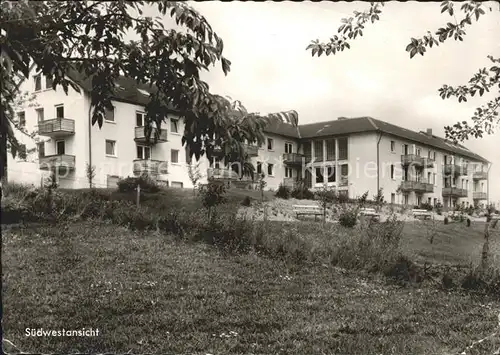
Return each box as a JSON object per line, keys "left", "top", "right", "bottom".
{"left": 306, "top": 1, "right": 500, "bottom": 143}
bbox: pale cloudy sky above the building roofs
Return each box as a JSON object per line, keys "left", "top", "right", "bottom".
{"left": 148, "top": 1, "right": 500, "bottom": 201}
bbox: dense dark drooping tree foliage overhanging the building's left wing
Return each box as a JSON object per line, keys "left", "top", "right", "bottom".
{"left": 0, "top": 1, "right": 297, "bottom": 181}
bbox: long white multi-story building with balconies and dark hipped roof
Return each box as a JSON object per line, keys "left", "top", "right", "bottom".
{"left": 9, "top": 73, "right": 490, "bottom": 207}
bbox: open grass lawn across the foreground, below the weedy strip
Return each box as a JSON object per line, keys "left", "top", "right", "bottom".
{"left": 2, "top": 223, "right": 500, "bottom": 355}
